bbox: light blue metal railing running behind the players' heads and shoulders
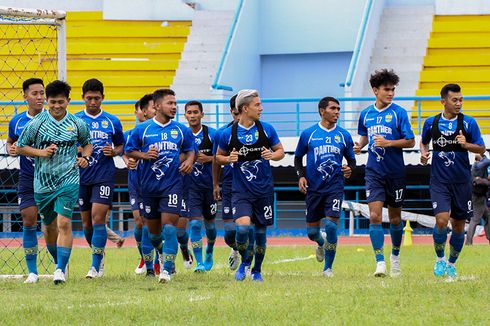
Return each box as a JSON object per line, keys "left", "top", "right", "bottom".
{"left": 0, "top": 95, "right": 490, "bottom": 137}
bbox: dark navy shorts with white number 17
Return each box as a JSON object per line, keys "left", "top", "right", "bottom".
{"left": 366, "top": 175, "right": 406, "bottom": 208}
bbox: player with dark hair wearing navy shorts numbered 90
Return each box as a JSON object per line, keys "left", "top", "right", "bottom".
{"left": 75, "top": 78, "right": 124, "bottom": 279}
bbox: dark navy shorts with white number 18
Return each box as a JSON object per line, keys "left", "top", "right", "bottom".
{"left": 141, "top": 192, "right": 182, "bottom": 220}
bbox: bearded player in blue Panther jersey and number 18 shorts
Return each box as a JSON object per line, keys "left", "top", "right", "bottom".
{"left": 125, "top": 89, "right": 195, "bottom": 283}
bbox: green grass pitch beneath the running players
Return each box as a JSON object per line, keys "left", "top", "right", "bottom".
{"left": 0, "top": 246, "right": 490, "bottom": 325}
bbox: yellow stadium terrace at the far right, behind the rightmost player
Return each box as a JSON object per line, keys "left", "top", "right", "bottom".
{"left": 417, "top": 15, "right": 490, "bottom": 134}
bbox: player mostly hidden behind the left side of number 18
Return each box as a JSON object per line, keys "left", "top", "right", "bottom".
{"left": 123, "top": 94, "right": 160, "bottom": 276}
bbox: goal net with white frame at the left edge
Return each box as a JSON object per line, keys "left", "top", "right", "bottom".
{"left": 0, "top": 7, "right": 64, "bottom": 275}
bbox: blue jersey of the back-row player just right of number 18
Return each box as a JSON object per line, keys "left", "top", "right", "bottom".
{"left": 190, "top": 126, "right": 216, "bottom": 190}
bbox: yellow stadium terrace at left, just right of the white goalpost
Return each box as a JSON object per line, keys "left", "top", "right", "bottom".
{"left": 0, "top": 12, "right": 192, "bottom": 129}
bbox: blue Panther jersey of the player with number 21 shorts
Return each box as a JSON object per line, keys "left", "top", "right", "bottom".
{"left": 294, "top": 123, "right": 355, "bottom": 193}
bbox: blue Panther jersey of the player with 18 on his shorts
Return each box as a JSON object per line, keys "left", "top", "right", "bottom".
{"left": 125, "top": 118, "right": 194, "bottom": 197}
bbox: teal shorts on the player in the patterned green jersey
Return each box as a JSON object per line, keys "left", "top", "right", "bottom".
{"left": 34, "top": 185, "right": 80, "bottom": 225}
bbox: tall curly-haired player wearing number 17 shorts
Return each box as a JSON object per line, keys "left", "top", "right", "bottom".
{"left": 354, "top": 69, "right": 415, "bottom": 277}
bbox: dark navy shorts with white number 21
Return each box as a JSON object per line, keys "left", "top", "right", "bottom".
{"left": 306, "top": 190, "right": 344, "bottom": 223}
